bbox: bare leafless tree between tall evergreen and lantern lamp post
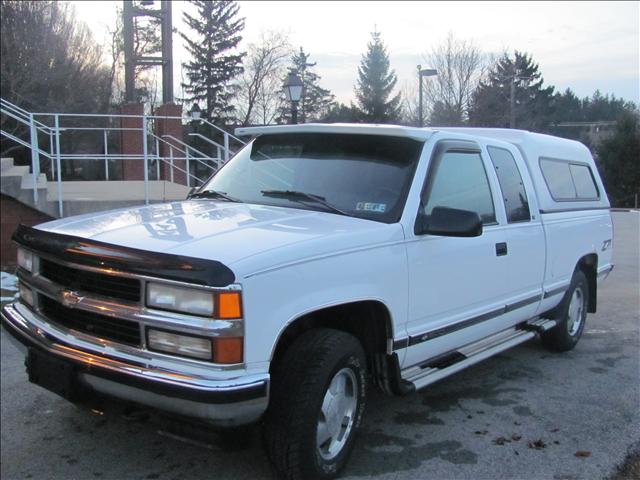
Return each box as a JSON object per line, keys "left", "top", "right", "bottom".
{"left": 237, "top": 31, "right": 291, "bottom": 125}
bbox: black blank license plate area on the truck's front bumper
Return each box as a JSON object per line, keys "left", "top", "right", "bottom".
{"left": 26, "top": 348, "right": 79, "bottom": 401}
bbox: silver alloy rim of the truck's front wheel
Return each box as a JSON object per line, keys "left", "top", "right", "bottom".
{"left": 316, "top": 368, "right": 358, "bottom": 460}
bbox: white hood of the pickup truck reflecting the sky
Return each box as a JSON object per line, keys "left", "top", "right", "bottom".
{"left": 36, "top": 199, "right": 404, "bottom": 278}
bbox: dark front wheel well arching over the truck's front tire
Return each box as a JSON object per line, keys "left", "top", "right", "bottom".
{"left": 270, "top": 300, "right": 393, "bottom": 372}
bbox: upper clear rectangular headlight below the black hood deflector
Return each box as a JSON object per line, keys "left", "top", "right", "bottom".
{"left": 147, "top": 282, "right": 215, "bottom": 317}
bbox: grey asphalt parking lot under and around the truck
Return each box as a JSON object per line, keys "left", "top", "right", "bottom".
{"left": 0, "top": 212, "right": 640, "bottom": 480}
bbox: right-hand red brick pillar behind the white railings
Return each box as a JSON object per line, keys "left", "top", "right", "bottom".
{"left": 155, "top": 103, "right": 186, "bottom": 185}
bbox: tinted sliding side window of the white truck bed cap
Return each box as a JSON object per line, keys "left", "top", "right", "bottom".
{"left": 540, "top": 158, "right": 600, "bottom": 201}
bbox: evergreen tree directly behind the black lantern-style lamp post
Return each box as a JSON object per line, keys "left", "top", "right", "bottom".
{"left": 278, "top": 47, "right": 335, "bottom": 123}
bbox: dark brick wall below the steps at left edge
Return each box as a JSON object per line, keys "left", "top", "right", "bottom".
{"left": 0, "top": 195, "right": 52, "bottom": 268}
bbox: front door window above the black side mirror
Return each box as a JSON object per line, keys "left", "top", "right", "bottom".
{"left": 422, "top": 151, "right": 496, "bottom": 225}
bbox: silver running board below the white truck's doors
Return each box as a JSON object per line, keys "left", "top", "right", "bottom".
{"left": 402, "top": 318, "right": 556, "bottom": 390}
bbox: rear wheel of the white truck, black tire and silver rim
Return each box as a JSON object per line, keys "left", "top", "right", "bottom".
{"left": 541, "top": 270, "right": 589, "bottom": 352}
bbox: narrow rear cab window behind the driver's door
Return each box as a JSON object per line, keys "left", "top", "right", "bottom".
{"left": 487, "top": 147, "right": 531, "bottom": 223}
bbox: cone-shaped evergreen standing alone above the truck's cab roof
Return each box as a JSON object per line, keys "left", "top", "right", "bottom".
{"left": 355, "top": 32, "right": 402, "bottom": 123}
